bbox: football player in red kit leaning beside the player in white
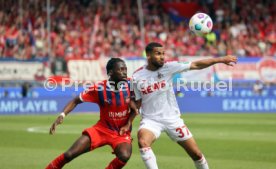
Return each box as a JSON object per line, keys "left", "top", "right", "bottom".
{"left": 46, "top": 58, "right": 138, "bottom": 169}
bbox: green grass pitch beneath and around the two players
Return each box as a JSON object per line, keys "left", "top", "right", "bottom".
{"left": 0, "top": 113, "right": 276, "bottom": 169}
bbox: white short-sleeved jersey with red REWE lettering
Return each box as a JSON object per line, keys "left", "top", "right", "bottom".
{"left": 133, "top": 62, "right": 191, "bottom": 120}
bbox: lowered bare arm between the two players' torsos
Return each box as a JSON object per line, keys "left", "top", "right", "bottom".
{"left": 119, "top": 100, "right": 139, "bottom": 135}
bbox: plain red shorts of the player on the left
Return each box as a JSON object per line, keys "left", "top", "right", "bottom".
{"left": 82, "top": 123, "right": 132, "bottom": 150}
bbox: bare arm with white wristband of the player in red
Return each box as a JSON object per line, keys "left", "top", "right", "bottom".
{"left": 49, "top": 97, "right": 82, "bottom": 134}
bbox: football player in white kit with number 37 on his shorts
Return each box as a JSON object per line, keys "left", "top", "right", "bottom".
{"left": 133, "top": 42, "right": 237, "bottom": 169}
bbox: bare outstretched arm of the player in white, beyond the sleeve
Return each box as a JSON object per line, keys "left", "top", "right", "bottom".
{"left": 190, "top": 55, "right": 237, "bottom": 70}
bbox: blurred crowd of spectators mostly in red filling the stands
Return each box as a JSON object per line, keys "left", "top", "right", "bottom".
{"left": 0, "top": 0, "right": 276, "bottom": 60}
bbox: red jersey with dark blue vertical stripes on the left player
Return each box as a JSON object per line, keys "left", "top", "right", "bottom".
{"left": 80, "top": 79, "right": 131, "bottom": 131}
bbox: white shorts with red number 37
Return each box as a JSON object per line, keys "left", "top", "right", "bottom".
{"left": 139, "top": 118, "right": 193, "bottom": 141}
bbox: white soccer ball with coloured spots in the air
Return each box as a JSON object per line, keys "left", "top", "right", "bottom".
{"left": 189, "top": 13, "right": 213, "bottom": 35}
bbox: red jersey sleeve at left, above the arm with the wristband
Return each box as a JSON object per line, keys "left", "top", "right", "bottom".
{"left": 79, "top": 85, "right": 99, "bottom": 103}
